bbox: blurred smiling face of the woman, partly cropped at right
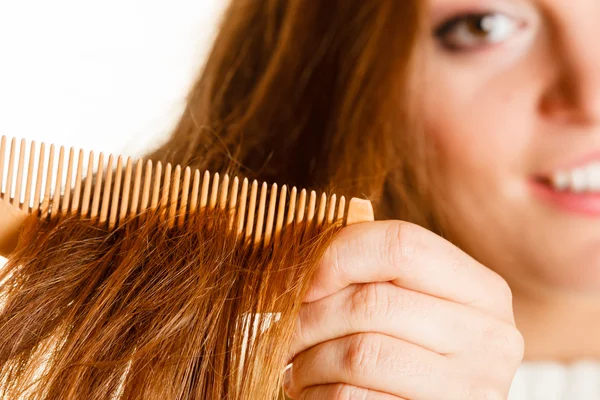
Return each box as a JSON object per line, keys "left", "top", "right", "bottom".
{"left": 424, "top": 0, "right": 600, "bottom": 294}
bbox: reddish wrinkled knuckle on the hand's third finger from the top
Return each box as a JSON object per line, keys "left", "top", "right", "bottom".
{"left": 343, "top": 333, "right": 381, "bottom": 377}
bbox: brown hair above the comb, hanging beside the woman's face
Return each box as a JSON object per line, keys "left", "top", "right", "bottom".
{"left": 149, "top": 0, "right": 435, "bottom": 229}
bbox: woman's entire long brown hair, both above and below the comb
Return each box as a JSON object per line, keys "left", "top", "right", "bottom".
{"left": 0, "top": 0, "right": 433, "bottom": 400}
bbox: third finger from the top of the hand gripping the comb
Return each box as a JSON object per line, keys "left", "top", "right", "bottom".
{"left": 287, "top": 333, "right": 456, "bottom": 400}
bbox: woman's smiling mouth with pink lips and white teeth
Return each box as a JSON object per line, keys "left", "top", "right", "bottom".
{"left": 531, "top": 161, "right": 600, "bottom": 217}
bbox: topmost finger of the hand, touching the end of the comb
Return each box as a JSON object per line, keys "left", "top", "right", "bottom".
{"left": 305, "top": 221, "right": 514, "bottom": 322}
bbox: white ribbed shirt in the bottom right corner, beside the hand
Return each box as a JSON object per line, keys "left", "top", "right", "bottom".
{"left": 508, "top": 361, "right": 600, "bottom": 400}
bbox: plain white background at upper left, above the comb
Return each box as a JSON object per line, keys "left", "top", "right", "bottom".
{"left": 0, "top": 0, "right": 227, "bottom": 265}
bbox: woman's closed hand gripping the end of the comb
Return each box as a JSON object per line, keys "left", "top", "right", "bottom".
{"left": 286, "top": 221, "right": 523, "bottom": 400}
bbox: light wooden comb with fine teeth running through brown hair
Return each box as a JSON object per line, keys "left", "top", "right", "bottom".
{"left": 0, "top": 136, "right": 374, "bottom": 257}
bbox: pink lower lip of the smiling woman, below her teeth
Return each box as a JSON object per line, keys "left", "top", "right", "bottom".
{"left": 530, "top": 179, "right": 600, "bottom": 217}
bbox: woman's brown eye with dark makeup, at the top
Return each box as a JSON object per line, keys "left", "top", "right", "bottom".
{"left": 435, "top": 13, "right": 519, "bottom": 51}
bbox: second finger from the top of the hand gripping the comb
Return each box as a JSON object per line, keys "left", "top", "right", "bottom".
{"left": 290, "top": 282, "right": 506, "bottom": 358}
